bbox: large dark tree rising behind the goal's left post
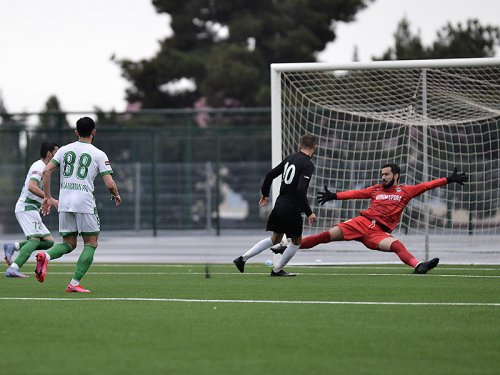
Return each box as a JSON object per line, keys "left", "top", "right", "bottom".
{"left": 117, "top": 0, "right": 374, "bottom": 108}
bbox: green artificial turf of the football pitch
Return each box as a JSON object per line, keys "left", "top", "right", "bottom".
{"left": 0, "top": 262, "right": 500, "bottom": 375}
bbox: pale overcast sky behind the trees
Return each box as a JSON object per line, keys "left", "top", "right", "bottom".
{"left": 0, "top": 0, "right": 500, "bottom": 113}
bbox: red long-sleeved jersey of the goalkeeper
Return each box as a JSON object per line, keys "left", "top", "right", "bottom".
{"left": 337, "top": 177, "right": 448, "bottom": 231}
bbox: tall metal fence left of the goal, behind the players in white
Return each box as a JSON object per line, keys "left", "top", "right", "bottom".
{"left": 0, "top": 110, "right": 271, "bottom": 234}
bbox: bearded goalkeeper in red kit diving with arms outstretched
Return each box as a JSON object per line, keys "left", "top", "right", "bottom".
{"left": 300, "top": 164, "right": 468, "bottom": 274}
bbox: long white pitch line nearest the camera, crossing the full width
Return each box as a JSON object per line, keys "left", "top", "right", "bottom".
{"left": 0, "top": 297, "right": 500, "bottom": 307}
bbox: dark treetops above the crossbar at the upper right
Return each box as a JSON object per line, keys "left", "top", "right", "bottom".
{"left": 373, "top": 18, "right": 500, "bottom": 60}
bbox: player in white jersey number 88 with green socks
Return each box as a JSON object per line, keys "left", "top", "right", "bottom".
{"left": 35, "top": 117, "right": 122, "bottom": 293}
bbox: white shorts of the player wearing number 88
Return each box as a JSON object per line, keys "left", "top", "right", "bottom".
{"left": 59, "top": 210, "right": 101, "bottom": 237}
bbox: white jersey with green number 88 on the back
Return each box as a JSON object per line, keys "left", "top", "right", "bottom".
{"left": 50, "top": 141, "right": 113, "bottom": 214}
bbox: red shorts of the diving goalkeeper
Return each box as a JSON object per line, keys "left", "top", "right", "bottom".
{"left": 337, "top": 216, "right": 392, "bottom": 250}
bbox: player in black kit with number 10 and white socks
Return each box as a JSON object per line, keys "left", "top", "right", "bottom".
{"left": 233, "top": 134, "right": 317, "bottom": 276}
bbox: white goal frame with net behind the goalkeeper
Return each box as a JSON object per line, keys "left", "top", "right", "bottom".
{"left": 271, "top": 58, "right": 500, "bottom": 264}
